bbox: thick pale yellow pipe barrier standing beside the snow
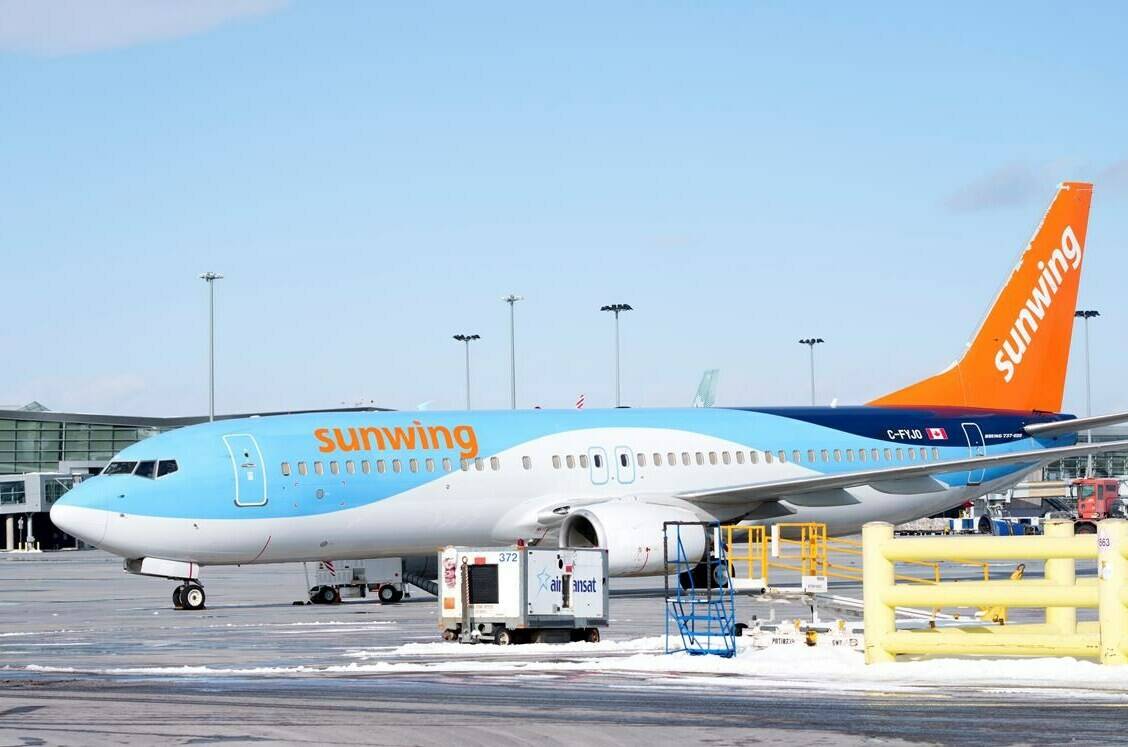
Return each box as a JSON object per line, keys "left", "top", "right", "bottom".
{"left": 862, "top": 519, "right": 1128, "bottom": 663}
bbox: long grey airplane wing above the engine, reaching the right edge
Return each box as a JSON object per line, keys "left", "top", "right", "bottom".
{"left": 677, "top": 440, "right": 1128, "bottom": 504}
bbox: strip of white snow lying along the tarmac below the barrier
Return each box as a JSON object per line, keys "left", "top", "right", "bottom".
{"left": 13, "top": 636, "right": 1128, "bottom": 701}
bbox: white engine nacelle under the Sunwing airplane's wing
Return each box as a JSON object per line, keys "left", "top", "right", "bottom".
{"left": 559, "top": 501, "right": 705, "bottom": 575}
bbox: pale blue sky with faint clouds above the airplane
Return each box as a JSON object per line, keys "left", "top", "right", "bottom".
{"left": 0, "top": 0, "right": 1128, "bottom": 415}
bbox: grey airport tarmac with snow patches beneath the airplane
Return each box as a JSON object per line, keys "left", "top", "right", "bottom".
{"left": 0, "top": 551, "right": 1128, "bottom": 747}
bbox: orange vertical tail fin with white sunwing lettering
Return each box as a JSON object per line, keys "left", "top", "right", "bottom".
{"left": 870, "top": 182, "right": 1093, "bottom": 412}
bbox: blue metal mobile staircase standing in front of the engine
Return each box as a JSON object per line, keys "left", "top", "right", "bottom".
{"left": 662, "top": 521, "right": 737, "bottom": 658}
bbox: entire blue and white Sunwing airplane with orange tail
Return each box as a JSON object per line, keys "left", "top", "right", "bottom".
{"left": 51, "top": 183, "right": 1128, "bottom": 608}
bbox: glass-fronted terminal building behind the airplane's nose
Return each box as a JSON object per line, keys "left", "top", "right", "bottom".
{"left": 0, "top": 402, "right": 381, "bottom": 550}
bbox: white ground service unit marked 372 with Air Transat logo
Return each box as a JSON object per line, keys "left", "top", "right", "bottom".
{"left": 439, "top": 546, "right": 608, "bottom": 645}
